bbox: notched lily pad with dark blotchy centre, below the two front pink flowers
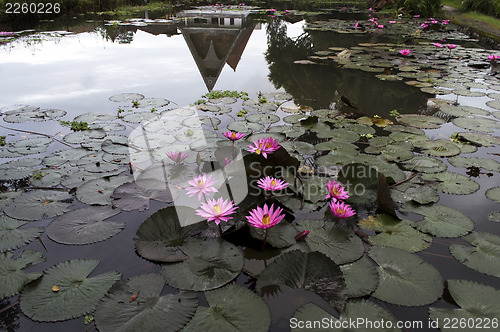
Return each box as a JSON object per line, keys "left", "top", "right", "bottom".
{"left": 161, "top": 238, "right": 244, "bottom": 291}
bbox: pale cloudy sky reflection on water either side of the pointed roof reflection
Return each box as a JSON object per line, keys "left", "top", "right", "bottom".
{"left": 0, "top": 24, "right": 274, "bottom": 117}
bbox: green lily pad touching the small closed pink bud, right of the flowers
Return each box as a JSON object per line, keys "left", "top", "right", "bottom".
{"left": 295, "top": 220, "right": 364, "bottom": 264}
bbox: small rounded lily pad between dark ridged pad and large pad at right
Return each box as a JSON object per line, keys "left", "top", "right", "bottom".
{"left": 340, "top": 256, "right": 378, "bottom": 298}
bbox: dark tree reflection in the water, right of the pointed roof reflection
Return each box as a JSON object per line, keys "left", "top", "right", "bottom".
{"left": 266, "top": 19, "right": 429, "bottom": 116}
